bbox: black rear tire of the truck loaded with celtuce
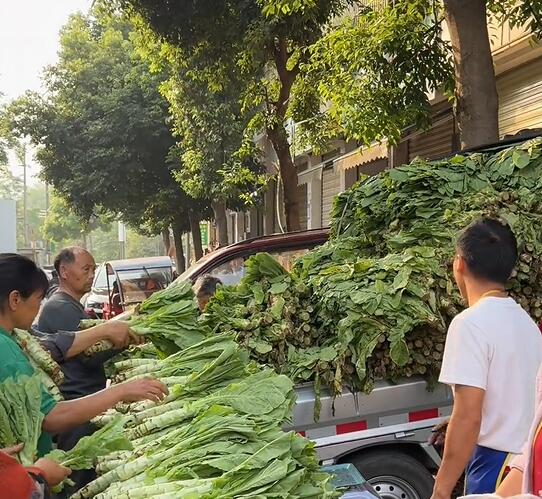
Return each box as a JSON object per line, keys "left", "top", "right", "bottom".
{"left": 350, "top": 450, "right": 434, "bottom": 499}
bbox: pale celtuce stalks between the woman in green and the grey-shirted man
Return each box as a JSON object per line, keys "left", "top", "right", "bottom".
{"left": 13, "top": 329, "right": 64, "bottom": 402}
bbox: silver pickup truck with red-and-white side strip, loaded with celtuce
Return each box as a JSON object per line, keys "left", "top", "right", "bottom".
{"left": 178, "top": 229, "right": 452, "bottom": 499}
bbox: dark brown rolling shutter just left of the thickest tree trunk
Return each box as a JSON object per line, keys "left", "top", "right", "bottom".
{"left": 408, "top": 108, "right": 454, "bottom": 161}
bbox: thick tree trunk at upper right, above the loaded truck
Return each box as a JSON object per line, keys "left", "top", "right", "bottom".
{"left": 444, "top": 0, "right": 499, "bottom": 149}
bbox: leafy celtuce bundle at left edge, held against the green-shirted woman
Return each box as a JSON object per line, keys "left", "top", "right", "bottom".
{"left": 0, "top": 375, "right": 43, "bottom": 466}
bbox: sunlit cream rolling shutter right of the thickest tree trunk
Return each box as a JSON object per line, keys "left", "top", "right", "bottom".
{"left": 497, "top": 58, "right": 542, "bottom": 136}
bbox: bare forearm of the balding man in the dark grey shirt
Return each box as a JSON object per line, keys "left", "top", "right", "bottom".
{"left": 66, "top": 321, "right": 141, "bottom": 359}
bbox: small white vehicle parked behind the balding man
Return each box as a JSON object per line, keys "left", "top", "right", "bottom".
{"left": 83, "top": 256, "right": 173, "bottom": 319}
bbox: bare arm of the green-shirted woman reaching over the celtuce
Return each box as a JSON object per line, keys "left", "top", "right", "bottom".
{"left": 42, "top": 379, "right": 167, "bottom": 433}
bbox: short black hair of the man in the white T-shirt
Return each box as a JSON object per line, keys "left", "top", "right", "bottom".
{"left": 457, "top": 218, "right": 518, "bottom": 284}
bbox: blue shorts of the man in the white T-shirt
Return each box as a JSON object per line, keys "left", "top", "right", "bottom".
{"left": 465, "top": 445, "right": 512, "bottom": 495}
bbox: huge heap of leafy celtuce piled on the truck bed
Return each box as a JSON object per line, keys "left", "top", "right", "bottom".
{"left": 204, "top": 139, "right": 542, "bottom": 393}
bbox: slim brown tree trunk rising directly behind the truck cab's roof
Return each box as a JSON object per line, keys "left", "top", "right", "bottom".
{"left": 268, "top": 127, "right": 301, "bottom": 232}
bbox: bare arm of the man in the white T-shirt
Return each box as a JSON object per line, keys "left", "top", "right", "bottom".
{"left": 432, "top": 385, "right": 485, "bottom": 499}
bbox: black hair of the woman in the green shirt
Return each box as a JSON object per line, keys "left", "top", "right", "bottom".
{"left": 0, "top": 253, "right": 49, "bottom": 309}
